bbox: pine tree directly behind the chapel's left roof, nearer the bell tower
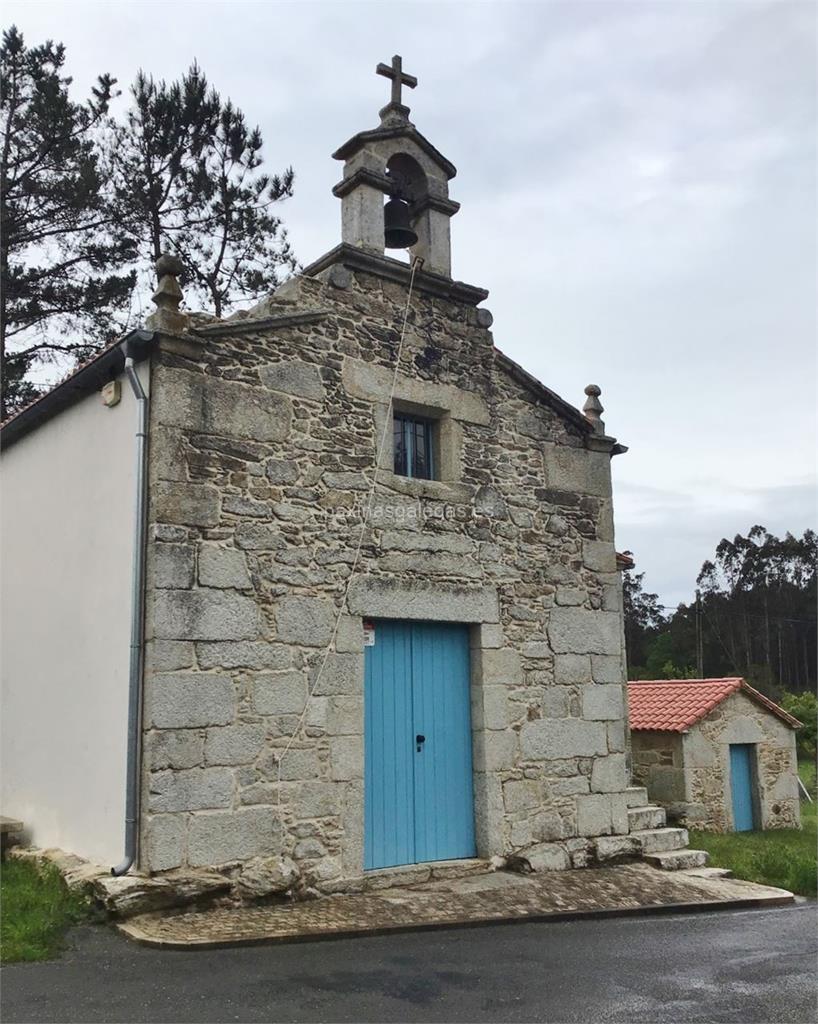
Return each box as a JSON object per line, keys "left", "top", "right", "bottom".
{"left": 111, "top": 63, "right": 296, "bottom": 316}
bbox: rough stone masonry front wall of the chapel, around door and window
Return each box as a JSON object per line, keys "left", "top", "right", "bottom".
{"left": 140, "top": 260, "right": 628, "bottom": 891}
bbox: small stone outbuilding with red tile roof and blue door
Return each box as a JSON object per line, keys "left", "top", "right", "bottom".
{"left": 628, "top": 678, "right": 801, "bottom": 831}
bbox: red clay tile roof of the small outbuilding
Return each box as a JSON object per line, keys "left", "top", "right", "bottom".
{"left": 628, "top": 677, "right": 801, "bottom": 732}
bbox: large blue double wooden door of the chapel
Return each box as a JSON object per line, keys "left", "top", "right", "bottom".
{"left": 363, "top": 622, "right": 476, "bottom": 869}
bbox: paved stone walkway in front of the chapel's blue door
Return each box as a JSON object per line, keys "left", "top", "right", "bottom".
{"left": 117, "top": 863, "right": 793, "bottom": 949}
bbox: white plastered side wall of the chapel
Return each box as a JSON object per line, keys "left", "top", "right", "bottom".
{"left": 0, "top": 362, "right": 148, "bottom": 863}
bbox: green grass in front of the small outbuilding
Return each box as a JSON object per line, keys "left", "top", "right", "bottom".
{"left": 690, "top": 761, "right": 818, "bottom": 896}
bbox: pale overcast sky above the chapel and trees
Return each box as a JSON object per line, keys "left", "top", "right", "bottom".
{"left": 4, "top": 0, "right": 818, "bottom": 605}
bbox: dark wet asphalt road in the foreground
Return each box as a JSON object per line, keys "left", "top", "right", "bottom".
{"left": 0, "top": 903, "right": 818, "bottom": 1024}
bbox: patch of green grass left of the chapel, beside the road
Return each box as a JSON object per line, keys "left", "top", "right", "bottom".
{"left": 0, "top": 860, "right": 92, "bottom": 964}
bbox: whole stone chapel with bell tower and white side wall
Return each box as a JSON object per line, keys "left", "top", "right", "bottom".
{"left": 2, "top": 57, "right": 703, "bottom": 892}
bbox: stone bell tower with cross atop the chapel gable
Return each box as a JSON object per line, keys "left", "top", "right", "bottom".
{"left": 333, "top": 55, "right": 460, "bottom": 278}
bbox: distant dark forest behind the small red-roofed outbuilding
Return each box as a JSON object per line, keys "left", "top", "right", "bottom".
{"left": 625, "top": 526, "right": 818, "bottom": 699}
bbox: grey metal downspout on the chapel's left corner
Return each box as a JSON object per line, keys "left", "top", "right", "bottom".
{"left": 111, "top": 356, "right": 148, "bottom": 876}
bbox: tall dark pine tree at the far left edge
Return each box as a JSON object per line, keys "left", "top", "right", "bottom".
{"left": 0, "top": 26, "right": 134, "bottom": 417}
